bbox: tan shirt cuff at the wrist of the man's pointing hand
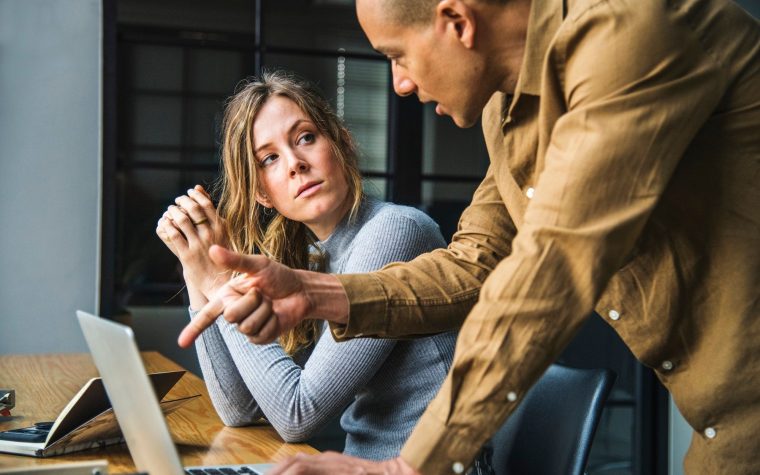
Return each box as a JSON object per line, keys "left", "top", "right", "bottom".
{"left": 330, "top": 274, "right": 388, "bottom": 341}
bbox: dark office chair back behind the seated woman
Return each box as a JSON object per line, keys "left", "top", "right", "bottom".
{"left": 491, "top": 365, "right": 616, "bottom": 475}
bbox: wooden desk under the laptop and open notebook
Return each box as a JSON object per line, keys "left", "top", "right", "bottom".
{"left": 0, "top": 352, "right": 317, "bottom": 473}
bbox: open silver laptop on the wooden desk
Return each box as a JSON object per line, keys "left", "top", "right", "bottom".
{"left": 77, "top": 310, "right": 273, "bottom": 475}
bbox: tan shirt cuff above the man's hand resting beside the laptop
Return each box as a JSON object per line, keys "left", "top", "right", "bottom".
{"left": 401, "top": 408, "right": 482, "bottom": 475}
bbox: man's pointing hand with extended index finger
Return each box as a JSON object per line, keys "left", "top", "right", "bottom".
{"left": 178, "top": 246, "right": 348, "bottom": 348}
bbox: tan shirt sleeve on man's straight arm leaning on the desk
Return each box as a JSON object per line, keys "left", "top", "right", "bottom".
{"left": 349, "top": 2, "right": 726, "bottom": 473}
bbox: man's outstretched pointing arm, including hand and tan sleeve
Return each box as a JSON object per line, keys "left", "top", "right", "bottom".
{"left": 179, "top": 165, "right": 515, "bottom": 347}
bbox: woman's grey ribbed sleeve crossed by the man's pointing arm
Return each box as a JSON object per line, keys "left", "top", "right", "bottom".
{"left": 199, "top": 206, "right": 444, "bottom": 442}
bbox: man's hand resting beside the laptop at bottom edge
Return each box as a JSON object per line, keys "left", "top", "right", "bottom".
{"left": 267, "top": 452, "right": 419, "bottom": 475}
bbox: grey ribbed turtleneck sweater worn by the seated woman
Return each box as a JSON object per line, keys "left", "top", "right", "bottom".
{"left": 191, "top": 198, "right": 456, "bottom": 460}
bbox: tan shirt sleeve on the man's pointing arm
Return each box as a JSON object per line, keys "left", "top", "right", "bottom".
{"left": 330, "top": 167, "right": 515, "bottom": 340}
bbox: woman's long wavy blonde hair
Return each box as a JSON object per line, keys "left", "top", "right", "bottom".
{"left": 219, "top": 71, "right": 363, "bottom": 355}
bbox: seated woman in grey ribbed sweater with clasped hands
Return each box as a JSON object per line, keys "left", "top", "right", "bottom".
{"left": 157, "top": 73, "right": 456, "bottom": 460}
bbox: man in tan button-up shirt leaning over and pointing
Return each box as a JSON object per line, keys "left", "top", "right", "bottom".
{"left": 180, "top": 0, "right": 760, "bottom": 474}
